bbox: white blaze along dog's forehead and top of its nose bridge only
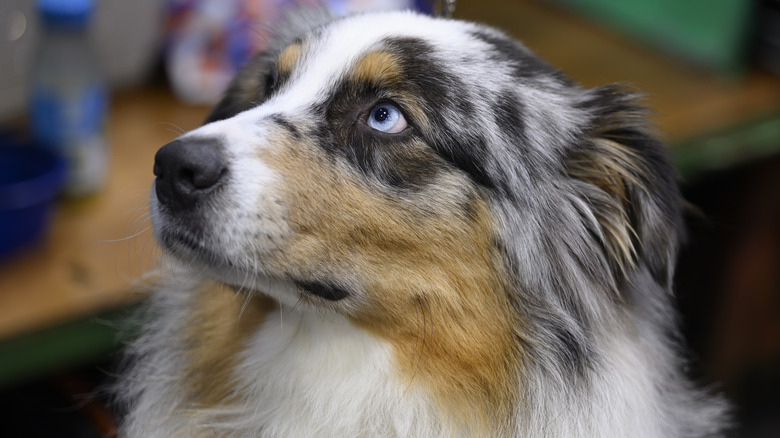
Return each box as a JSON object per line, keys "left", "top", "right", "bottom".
{"left": 191, "top": 12, "right": 497, "bottom": 138}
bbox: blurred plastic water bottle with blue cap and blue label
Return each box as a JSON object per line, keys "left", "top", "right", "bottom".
{"left": 30, "top": 0, "right": 108, "bottom": 197}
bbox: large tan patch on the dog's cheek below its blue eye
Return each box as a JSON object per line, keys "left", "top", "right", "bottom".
{"left": 262, "top": 138, "right": 520, "bottom": 431}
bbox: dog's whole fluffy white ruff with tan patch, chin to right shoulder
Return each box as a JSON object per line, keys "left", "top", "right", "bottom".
{"left": 124, "top": 270, "right": 720, "bottom": 438}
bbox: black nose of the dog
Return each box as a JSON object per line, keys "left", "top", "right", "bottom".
{"left": 154, "top": 138, "right": 227, "bottom": 210}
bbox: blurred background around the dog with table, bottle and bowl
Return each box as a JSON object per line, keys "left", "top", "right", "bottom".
{"left": 0, "top": 0, "right": 780, "bottom": 438}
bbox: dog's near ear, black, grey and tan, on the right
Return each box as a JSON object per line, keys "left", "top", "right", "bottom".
{"left": 566, "top": 86, "right": 682, "bottom": 288}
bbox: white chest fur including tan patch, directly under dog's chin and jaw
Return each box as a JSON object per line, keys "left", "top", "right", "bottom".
{"left": 125, "top": 276, "right": 463, "bottom": 437}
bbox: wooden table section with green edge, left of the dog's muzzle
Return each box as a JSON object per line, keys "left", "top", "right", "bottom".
{"left": 0, "top": 88, "right": 208, "bottom": 384}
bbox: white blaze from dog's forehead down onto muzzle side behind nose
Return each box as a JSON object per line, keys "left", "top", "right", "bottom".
{"left": 176, "top": 12, "right": 516, "bottom": 184}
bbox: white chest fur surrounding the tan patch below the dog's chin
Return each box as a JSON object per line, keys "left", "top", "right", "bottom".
{"left": 125, "top": 267, "right": 453, "bottom": 438}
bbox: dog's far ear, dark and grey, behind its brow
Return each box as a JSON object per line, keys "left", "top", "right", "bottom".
{"left": 204, "top": 4, "right": 335, "bottom": 124}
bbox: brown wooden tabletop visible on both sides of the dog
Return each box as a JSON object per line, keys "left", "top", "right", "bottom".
{"left": 0, "top": 0, "right": 780, "bottom": 385}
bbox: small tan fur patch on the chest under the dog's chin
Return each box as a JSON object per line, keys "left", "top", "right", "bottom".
{"left": 180, "top": 283, "right": 277, "bottom": 408}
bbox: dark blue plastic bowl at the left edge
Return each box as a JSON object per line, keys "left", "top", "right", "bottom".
{"left": 0, "top": 142, "right": 67, "bottom": 258}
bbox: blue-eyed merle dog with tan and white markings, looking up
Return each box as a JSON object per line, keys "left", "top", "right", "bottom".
{"left": 121, "top": 6, "right": 728, "bottom": 438}
